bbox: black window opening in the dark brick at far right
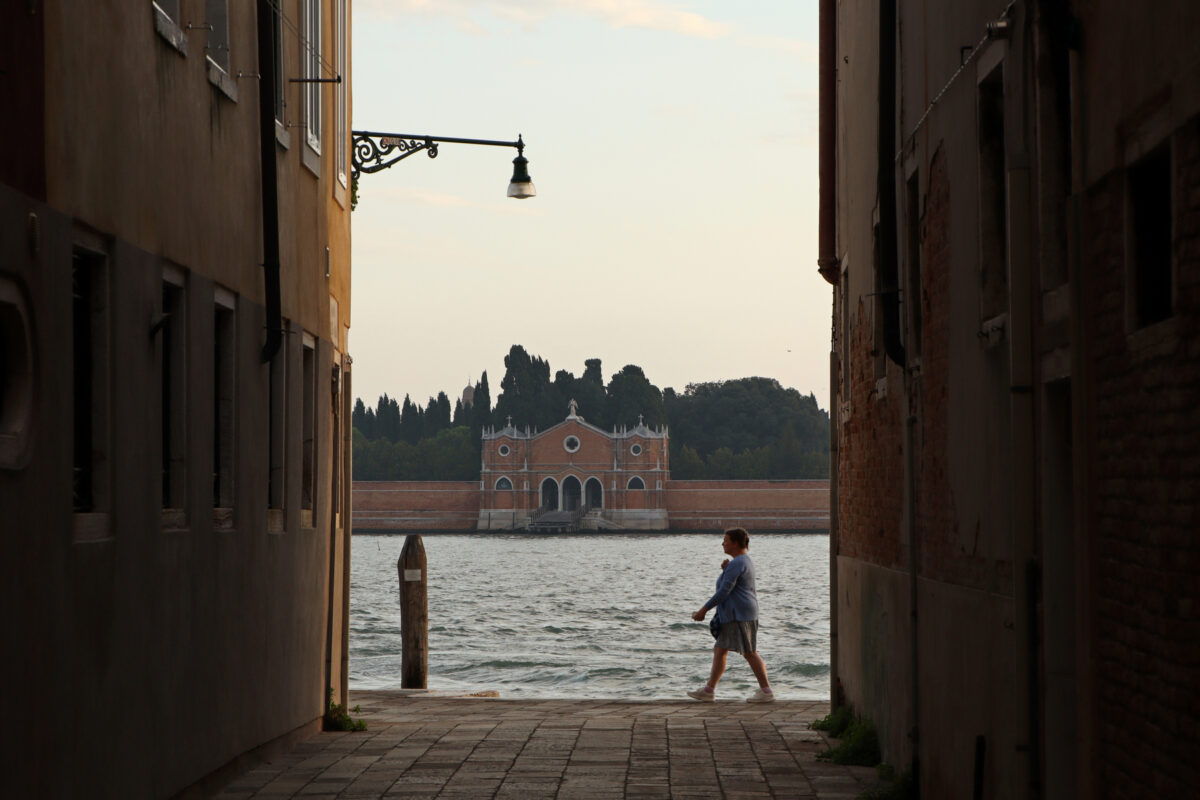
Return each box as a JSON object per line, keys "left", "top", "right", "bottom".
{"left": 1126, "top": 143, "right": 1172, "bottom": 329}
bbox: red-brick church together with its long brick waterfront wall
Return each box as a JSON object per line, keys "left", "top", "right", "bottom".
{"left": 353, "top": 399, "right": 829, "bottom": 534}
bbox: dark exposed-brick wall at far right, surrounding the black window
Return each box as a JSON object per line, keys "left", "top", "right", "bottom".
{"left": 1085, "top": 118, "right": 1200, "bottom": 796}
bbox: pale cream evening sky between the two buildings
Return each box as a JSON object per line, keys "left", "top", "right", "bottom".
{"left": 350, "top": 0, "right": 830, "bottom": 415}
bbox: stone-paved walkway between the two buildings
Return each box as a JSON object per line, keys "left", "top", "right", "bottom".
{"left": 218, "top": 692, "right": 875, "bottom": 800}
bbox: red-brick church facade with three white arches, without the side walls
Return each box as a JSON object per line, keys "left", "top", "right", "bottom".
{"left": 476, "top": 401, "right": 670, "bottom": 530}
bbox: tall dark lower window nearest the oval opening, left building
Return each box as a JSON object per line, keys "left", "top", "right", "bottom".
{"left": 71, "top": 248, "right": 109, "bottom": 541}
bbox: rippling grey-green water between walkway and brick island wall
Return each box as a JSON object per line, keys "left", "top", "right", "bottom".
{"left": 350, "top": 534, "right": 829, "bottom": 699}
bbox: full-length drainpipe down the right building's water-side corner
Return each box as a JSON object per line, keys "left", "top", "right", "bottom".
{"left": 817, "top": 0, "right": 847, "bottom": 709}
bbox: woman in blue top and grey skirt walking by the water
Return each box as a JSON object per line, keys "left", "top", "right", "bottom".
{"left": 688, "top": 528, "right": 775, "bottom": 703}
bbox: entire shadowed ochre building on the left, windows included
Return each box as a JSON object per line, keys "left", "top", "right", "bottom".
{"left": 0, "top": 0, "right": 352, "bottom": 798}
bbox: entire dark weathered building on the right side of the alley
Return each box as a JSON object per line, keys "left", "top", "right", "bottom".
{"left": 818, "top": 0, "right": 1200, "bottom": 798}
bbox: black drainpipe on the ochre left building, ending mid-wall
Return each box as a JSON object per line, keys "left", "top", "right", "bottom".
{"left": 258, "top": 0, "right": 283, "bottom": 363}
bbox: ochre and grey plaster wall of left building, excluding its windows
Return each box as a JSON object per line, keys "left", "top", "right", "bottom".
{"left": 0, "top": 0, "right": 349, "bottom": 798}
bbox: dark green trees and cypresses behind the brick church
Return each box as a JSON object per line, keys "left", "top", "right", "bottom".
{"left": 353, "top": 344, "right": 829, "bottom": 481}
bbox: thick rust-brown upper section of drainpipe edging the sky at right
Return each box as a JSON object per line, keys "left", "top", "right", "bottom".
{"left": 817, "top": 0, "right": 841, "bottom": 285}
